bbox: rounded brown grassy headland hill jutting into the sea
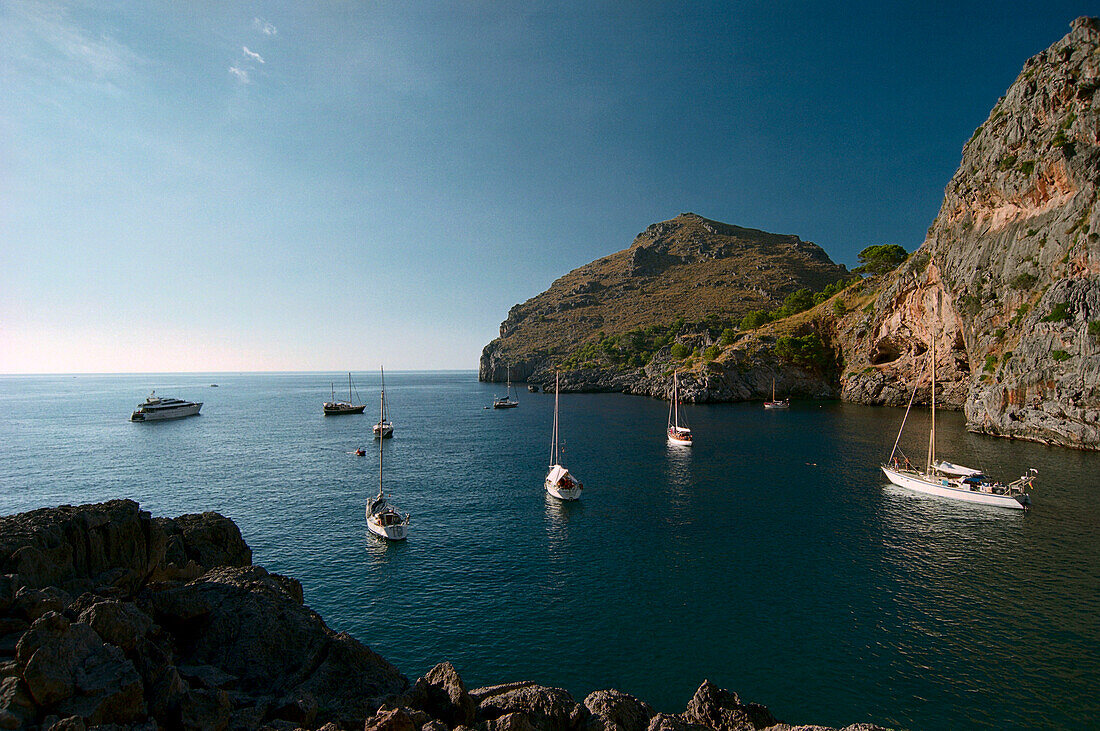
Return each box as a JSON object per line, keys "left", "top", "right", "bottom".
{"left": 480, "top": 213, "right": 849, "bottom": 390}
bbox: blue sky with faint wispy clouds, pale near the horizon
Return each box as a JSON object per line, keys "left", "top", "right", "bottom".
{"left": 0, "top": 0, "right": 1100, "bottom": 374}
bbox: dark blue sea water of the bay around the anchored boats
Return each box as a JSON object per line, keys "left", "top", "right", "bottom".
{"left": 0, "top": 373, "right": 1100, "bottom": 729}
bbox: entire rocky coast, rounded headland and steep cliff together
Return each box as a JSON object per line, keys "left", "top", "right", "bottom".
{"left": 481, "top": 18, "right": 1100, "bottom": 450}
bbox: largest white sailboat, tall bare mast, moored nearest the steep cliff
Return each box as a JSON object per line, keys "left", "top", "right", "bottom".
{"left": 881, "top": 305, "right": 1038, "bottom": 510}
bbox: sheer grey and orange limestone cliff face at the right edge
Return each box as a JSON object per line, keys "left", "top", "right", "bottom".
{"left": 838, "top": 18, "right": 1100, "bottom": 448}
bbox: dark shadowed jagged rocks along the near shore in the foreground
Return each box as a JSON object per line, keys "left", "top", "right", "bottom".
{"left": 0, "top": 500, "right": 878, "bottom": 731}
